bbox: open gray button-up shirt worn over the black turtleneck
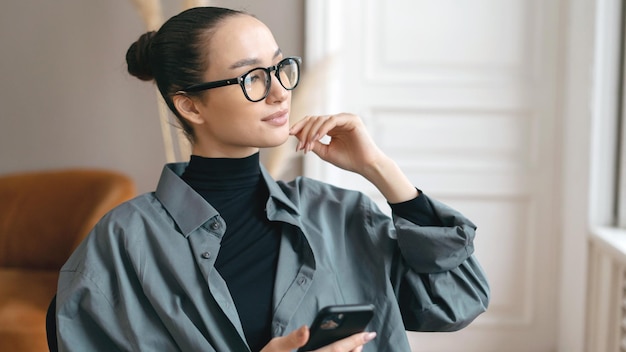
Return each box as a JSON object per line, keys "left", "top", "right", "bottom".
{"left": 57, "top": 163, "right": 489, "bottom": 352}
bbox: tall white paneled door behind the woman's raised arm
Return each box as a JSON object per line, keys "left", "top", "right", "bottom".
{"left": 305, "top": 0, "right": 560, "bottom": 352}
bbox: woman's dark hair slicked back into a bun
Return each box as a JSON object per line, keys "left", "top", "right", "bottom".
{"left": 126, "top": 7, "right": 247, "bottom": 141}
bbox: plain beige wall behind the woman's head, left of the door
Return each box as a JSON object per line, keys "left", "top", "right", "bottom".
{"left": 0, "top": 0, "right": 304, "bottom": 192}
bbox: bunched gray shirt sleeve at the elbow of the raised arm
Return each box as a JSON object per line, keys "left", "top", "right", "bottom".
{"left": 382, "top": 191, "right": 490, "bottom": 331}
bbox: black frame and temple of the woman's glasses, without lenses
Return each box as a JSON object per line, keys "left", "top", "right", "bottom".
{"left": 177, "top": 56, "right": 302, "bottom": 103}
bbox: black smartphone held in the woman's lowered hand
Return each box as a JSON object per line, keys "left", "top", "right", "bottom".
{"left": 298, "top": 304, "right": 374, "bottom": 352}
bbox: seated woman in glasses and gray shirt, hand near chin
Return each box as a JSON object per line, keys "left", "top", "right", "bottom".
{"left": 57, "top": 7, "right": 489, "bottom": 352}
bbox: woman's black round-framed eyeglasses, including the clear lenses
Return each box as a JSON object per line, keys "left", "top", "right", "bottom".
{"left": 180, "top": 56, "right": 302, "bottom": 102}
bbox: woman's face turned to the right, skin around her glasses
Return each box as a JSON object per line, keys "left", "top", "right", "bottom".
{"left": 193, "top": 15, "right": 291, "bottom": 158}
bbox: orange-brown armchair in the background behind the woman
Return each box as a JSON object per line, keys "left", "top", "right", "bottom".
{"left": 0, "top": 169, "right": 135, "bottom": 352}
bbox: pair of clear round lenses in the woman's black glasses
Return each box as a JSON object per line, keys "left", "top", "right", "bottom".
{"left": 243, "top": 58, "right": 300, "bottom": 101}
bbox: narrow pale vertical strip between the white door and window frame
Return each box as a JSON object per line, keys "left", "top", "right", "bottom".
{"left": 557, "top": 0, "right": 595, "bottom": 352}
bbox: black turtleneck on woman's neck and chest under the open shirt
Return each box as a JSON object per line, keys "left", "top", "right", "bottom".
{"left": 182, "top": 153, "right": 280, "bottom": 351}
